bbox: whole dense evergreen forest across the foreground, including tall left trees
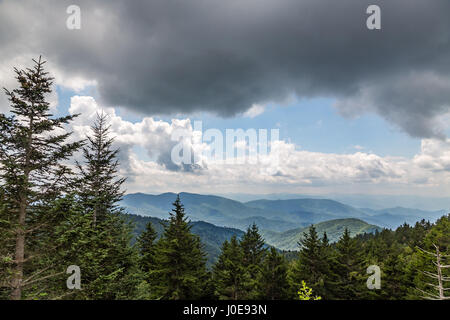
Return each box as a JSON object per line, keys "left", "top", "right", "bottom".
{"left": 0, "top": 59, "right": 450, "bottom": 300}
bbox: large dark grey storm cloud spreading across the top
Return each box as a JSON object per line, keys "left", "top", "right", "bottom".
{"left": 0, "top": 0, "right": 450, "bottom": 137}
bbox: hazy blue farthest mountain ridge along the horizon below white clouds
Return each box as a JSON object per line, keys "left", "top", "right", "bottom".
{"left": 121, "top": 192, "right": 445, "bottom": 232}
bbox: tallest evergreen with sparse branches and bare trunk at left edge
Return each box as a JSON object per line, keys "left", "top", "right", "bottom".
{"left": 0, "top": 57, "right": 81, "bottom": 300}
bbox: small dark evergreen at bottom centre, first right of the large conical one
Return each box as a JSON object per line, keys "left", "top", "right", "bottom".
{"left": 213, "top": 236, "right": 248, "bottom": 300}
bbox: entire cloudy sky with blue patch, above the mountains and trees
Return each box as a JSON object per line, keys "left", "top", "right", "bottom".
{"left": 0, "top": 0, "right": 450, "bottom": 197}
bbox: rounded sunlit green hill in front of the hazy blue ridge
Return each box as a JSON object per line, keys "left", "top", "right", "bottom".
{"left": 261, "top": 218, "right": 382, "bottom": 250}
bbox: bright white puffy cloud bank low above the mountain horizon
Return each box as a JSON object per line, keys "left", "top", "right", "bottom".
{"left": 69, "top": 96, "right": 450, "bottom": 194}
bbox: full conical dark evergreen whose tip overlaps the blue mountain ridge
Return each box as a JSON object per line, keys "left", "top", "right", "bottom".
{"left": 153, "top": 196, "right": 207, "bottom": 300}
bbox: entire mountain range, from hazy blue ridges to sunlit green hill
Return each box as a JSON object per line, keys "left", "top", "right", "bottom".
{"left": 121, "top": 192, "right": 446, "bottom": 265}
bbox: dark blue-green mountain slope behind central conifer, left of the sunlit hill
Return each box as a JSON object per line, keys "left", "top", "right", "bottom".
{"left": 127, "top": 214, "right": 244, "bottom": 265}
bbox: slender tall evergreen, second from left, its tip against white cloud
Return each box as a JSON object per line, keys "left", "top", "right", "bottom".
{"left": 66, "top": 114, "right": 141, "bottom": 299}
